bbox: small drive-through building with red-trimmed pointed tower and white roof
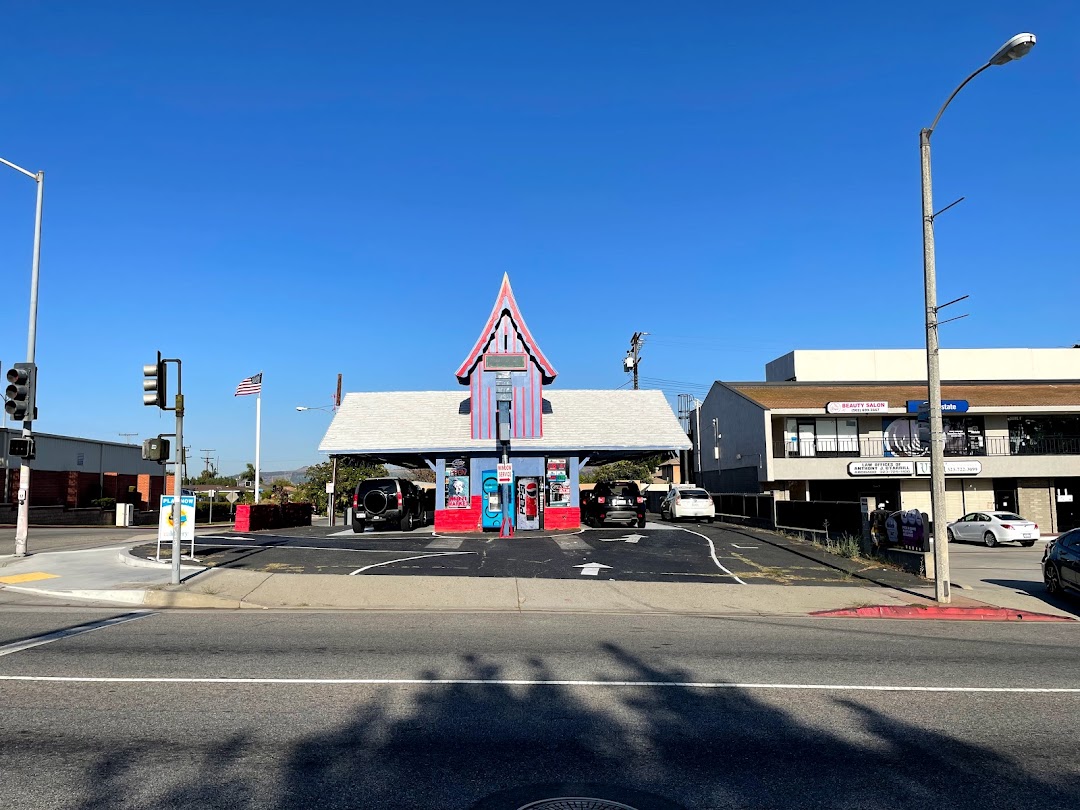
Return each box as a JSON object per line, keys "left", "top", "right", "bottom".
{"left": 319, "top": 276, "right": 690, "bottom": 531}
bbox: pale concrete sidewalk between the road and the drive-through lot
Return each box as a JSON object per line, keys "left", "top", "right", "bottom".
{"left": 0, "top": 542, "right": 1069, "bottom": 616}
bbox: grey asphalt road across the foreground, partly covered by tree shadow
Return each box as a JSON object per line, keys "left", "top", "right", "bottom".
{"left": 0, "top": 609, "right": 1080, "bottom": 810}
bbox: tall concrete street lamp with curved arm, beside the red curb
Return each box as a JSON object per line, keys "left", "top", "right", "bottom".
{"left": 919, "top": 33, "right": 1035, "bottom": 604}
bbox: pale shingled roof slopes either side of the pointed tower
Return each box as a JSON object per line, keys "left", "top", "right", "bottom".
{"left": 319, "top": 390, "right": 690, "bottom": 458}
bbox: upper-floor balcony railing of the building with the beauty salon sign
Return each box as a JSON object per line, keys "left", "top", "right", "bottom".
{"left": 773, "top": 435, "right": 1080, "bottom": 458}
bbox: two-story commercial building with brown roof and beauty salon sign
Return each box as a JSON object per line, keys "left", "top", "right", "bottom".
{"left": 690, "top": 349, "right": 1080, "bottom": 532}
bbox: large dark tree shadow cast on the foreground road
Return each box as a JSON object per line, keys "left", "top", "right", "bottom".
{"left": 70, "top": 645, "right": 1080, "bottom": 810}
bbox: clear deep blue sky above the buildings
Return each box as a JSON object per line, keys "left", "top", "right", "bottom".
{"left": 0, "top": 0, "right": 1080, "bottom": 472}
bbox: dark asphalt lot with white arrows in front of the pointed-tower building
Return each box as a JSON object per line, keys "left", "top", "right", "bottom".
{"left": 134, "top": 522, "right": 865, "bottom": 585}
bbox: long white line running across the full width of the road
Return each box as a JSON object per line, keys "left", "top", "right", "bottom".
{"left": 0, "top": 675, "right": 1080, "bottom": 694}
